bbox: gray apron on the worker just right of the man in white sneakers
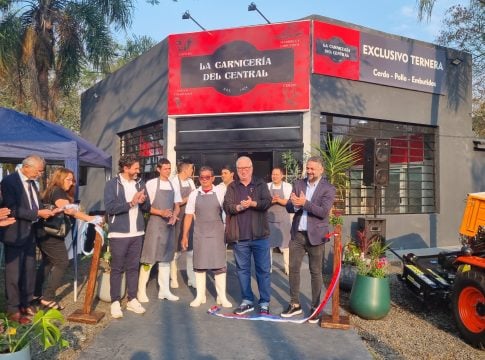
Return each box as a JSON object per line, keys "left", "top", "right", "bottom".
{"left": 140, "top": 178, "right": 175, "bottom": 264}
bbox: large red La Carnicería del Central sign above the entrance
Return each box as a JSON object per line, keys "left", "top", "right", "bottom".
{"left": 168, "top": 21, "right": 310, "bottom": 115}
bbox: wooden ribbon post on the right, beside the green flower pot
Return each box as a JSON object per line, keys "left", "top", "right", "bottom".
{"left": 320, "top": 224, "right": 350, "bottom": 330}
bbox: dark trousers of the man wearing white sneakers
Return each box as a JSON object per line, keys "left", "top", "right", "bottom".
{"left": 109, "top": 236, "right": 143, "bottom": 302}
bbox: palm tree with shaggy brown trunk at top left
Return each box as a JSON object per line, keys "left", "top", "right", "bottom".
{"left": 0, "top": 0, "right": 133, "bottom": 120}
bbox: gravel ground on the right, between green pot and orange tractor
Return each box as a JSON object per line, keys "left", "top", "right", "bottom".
{"left": 340, "top": 266, "right": 485, "bottom": 360}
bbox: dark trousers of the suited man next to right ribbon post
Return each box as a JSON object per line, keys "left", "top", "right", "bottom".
{"left": 289, "top": 232, "right": 325, "bottom": 307}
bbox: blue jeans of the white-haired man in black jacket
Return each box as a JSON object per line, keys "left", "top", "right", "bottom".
{"left": 233, "top": 239, "right": 271, "bottom": 306}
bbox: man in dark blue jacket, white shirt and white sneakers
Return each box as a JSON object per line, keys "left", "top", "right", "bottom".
{"left": 104, "top": 155, "right": 150, "bottom": 318}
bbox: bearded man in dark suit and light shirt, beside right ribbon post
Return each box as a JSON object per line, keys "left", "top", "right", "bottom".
{"left": 281, "top": 156, "right": 335, "bottom": 321}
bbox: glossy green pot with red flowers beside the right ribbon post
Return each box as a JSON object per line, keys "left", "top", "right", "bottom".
{"left": 350, "top": 236, "right": 391, "bottom": 320}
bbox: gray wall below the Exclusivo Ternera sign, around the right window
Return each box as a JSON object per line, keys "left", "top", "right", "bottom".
{"left": 311, "top": 43, "right": 472, "bottom": 249}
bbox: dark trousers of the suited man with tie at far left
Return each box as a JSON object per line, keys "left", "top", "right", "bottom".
{"left": 5, "top": 236, "right": 35, "bottom": 313}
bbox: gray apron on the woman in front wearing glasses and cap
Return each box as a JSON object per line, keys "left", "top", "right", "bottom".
{"left": 194, "top": 193, "right": 226, "bottom": 270}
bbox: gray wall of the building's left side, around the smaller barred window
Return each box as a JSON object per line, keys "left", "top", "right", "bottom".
{"left": 80, "top": 39, "right": 168, "bottom": 210}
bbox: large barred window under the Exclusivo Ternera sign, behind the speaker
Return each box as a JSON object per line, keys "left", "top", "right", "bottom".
{"left": 320, "top": 114, "right": 437, "bottom": 215}
